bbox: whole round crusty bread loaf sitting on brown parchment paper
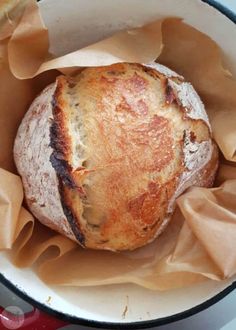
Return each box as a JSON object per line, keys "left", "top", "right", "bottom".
{"left": 14, "top": 63, "right": 218, "bottom": 251}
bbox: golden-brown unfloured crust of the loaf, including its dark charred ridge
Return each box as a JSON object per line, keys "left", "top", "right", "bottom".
{"left": 47, "top": 64, "right": 218, "bottom": 250}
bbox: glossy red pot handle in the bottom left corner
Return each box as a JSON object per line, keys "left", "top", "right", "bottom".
{"left": 0, "top": 306, "right": 69, "bottom": 330}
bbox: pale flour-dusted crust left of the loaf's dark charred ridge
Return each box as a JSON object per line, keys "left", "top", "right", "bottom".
{"left": 14, "top": 83, "right": 75, "bottom": 239}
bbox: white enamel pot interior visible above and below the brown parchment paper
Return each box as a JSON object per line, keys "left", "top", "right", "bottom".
{"left": 0, "top": 0, "right": 236, "bottom": 329}
